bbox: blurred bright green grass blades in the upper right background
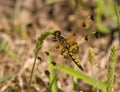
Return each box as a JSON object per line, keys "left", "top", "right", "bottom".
{"left": 95, "top": 0, "right": 118, "bottom": 34}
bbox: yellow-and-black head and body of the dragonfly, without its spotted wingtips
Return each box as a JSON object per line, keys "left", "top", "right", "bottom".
{"left": 53, "top": 31, "right": 83, "bottom": 71}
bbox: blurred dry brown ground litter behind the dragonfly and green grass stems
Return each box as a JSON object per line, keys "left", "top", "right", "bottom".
{"left": 0, "top": 0, "right": 120, "bottom": 92}
